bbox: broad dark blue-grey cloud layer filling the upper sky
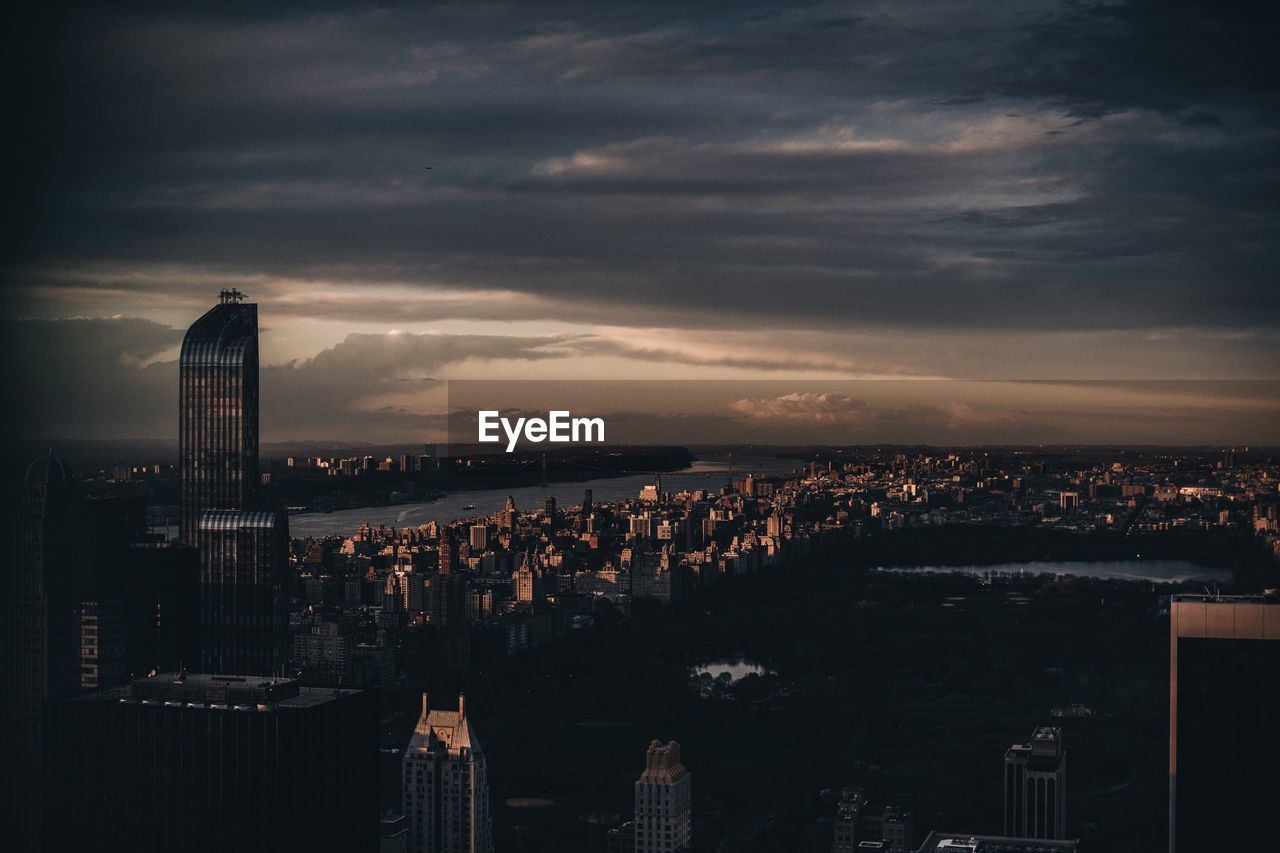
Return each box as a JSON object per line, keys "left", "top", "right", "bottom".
{"left": 8, "top": 0, "right": 1280, "bottom": 370}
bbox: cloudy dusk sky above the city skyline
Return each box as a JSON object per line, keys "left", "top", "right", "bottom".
{"left": 3, "top": 0, "right": 1280, "bottom": 443}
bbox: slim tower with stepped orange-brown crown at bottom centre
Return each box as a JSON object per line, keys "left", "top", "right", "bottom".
{"left": 636, "top": 740, "right": 694, "bottom": 853}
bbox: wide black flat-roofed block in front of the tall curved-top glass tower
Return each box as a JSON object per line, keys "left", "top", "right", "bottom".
{"left": 47, "top": 672, "right": 379, "bottom": 853}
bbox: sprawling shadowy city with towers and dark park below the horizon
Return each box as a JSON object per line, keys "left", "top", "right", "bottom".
{"left": 5, "top": 289, "right": 1280, "bottom": 853}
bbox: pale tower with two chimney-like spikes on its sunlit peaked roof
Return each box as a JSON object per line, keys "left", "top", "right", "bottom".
{"left": 401, "top": 693, "right": 493, "bottom": 853}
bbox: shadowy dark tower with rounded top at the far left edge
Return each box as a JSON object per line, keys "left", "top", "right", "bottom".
{"left": 3, "top": 452, "right": 83, "bottom": 850}
